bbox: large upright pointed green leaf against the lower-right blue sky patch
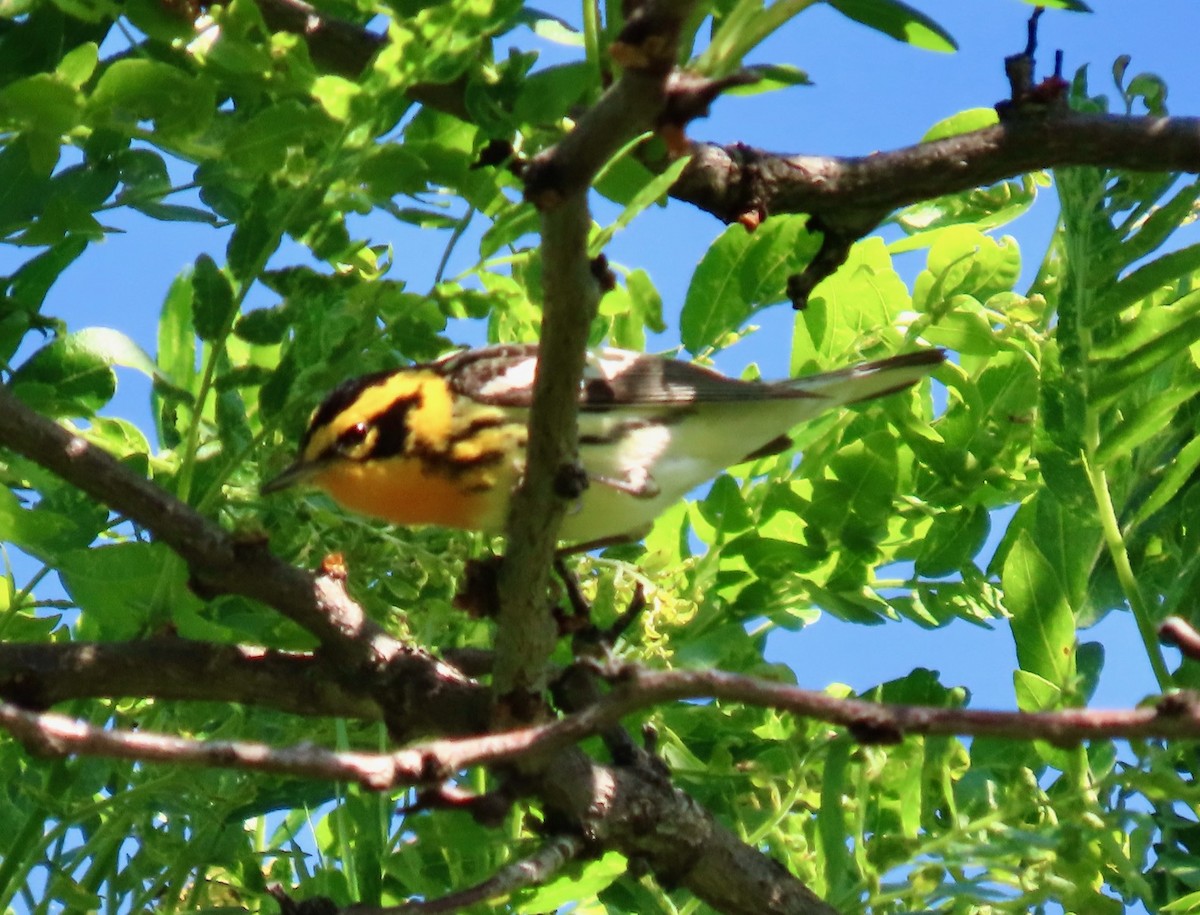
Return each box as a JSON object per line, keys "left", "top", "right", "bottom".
{"left": 1001, "top": 532, "right": 1075, "bottom": 692}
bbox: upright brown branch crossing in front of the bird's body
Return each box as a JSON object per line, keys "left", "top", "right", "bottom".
{"left": 493, "top": 0, "right": 694, "bottom": 701}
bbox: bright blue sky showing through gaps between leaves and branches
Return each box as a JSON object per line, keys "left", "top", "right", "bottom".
{"left": 0, "top": 0, "right": 1200, "bottom": 707}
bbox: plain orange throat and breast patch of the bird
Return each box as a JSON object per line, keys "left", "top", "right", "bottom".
{"left": 313, "top": 458, "right": 509, "bottom": 531}
